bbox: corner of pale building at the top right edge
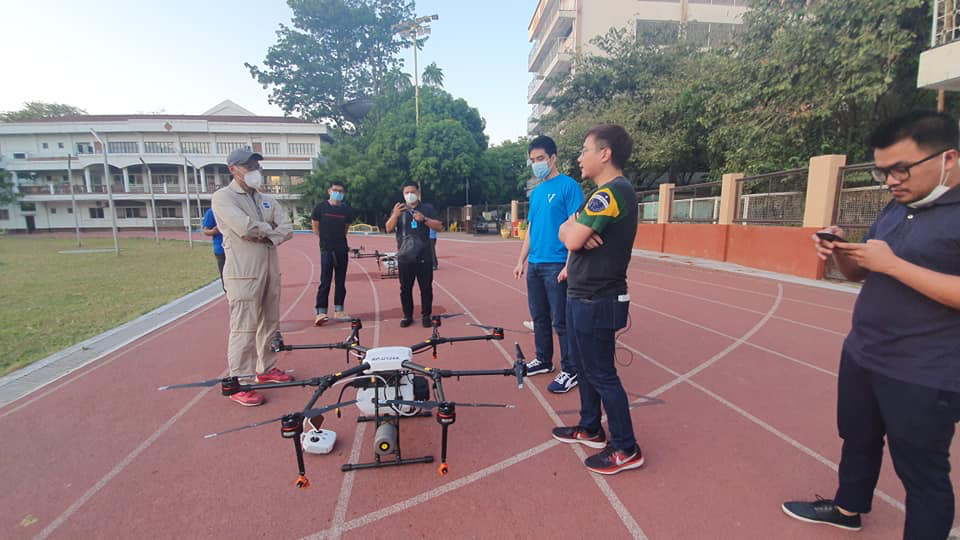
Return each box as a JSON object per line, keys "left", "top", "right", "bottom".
{"left": 917, "top": 0, "right": 960, "bottom": 92}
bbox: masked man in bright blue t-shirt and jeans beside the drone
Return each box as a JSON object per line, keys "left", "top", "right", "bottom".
{"left": 513, "top": 135, "right": 583, "bottom": 394}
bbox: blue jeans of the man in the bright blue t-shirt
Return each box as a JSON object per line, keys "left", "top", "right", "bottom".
{"left": 527, "top": 263, "right": 577, "bottom": 374}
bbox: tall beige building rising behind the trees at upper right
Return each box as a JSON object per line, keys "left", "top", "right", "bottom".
{"left": 527, "top": 0, "right": 749, "bottom": 134}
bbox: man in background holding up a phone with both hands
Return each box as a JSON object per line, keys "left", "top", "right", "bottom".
{"left": 386, "top": 182, "right": 443, "bottom": 328}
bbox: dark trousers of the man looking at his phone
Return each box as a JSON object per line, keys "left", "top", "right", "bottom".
{"left": 834, "top": 351, "right": 960, "bottom": 540}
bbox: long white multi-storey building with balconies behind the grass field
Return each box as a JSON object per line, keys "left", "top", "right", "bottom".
{"left": 0, "top": 100, "right": 330, "bottom": 231}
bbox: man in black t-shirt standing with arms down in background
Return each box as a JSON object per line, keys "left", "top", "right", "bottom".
{"left": 310, "top": 180, "right": 353, "bottom": 326}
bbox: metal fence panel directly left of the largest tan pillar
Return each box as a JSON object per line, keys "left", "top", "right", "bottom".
{"left": 734, "top": 169, "right": 807, "bottom": 227}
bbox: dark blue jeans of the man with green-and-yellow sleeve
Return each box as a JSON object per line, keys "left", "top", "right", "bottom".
{"left": 567, "top": 296, "right": 637, "bottom": 452}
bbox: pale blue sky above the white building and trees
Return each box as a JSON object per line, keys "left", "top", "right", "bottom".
{"left": 0, "top": 0, "right": 537, "bottom": 144}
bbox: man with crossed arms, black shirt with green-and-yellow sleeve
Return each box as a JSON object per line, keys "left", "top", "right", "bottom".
{"left": 553, "top": 124, "right": 643, "bottom": 474}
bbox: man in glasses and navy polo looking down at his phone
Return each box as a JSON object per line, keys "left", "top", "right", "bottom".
{"left": 783, "top": 112, "right": 960, "bottom": 539}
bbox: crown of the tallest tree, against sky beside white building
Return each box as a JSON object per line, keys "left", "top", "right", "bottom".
{"left": 244, "top": 0, "right": 414, "bottom": 127}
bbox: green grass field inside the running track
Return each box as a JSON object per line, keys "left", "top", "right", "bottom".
{"left": 0, "top": 236, "right": 218, "bottom": 375}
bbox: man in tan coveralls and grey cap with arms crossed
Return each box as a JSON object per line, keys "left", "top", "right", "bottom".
{"left": 213, "top": 148, "right": 293, "bottom": 407}
